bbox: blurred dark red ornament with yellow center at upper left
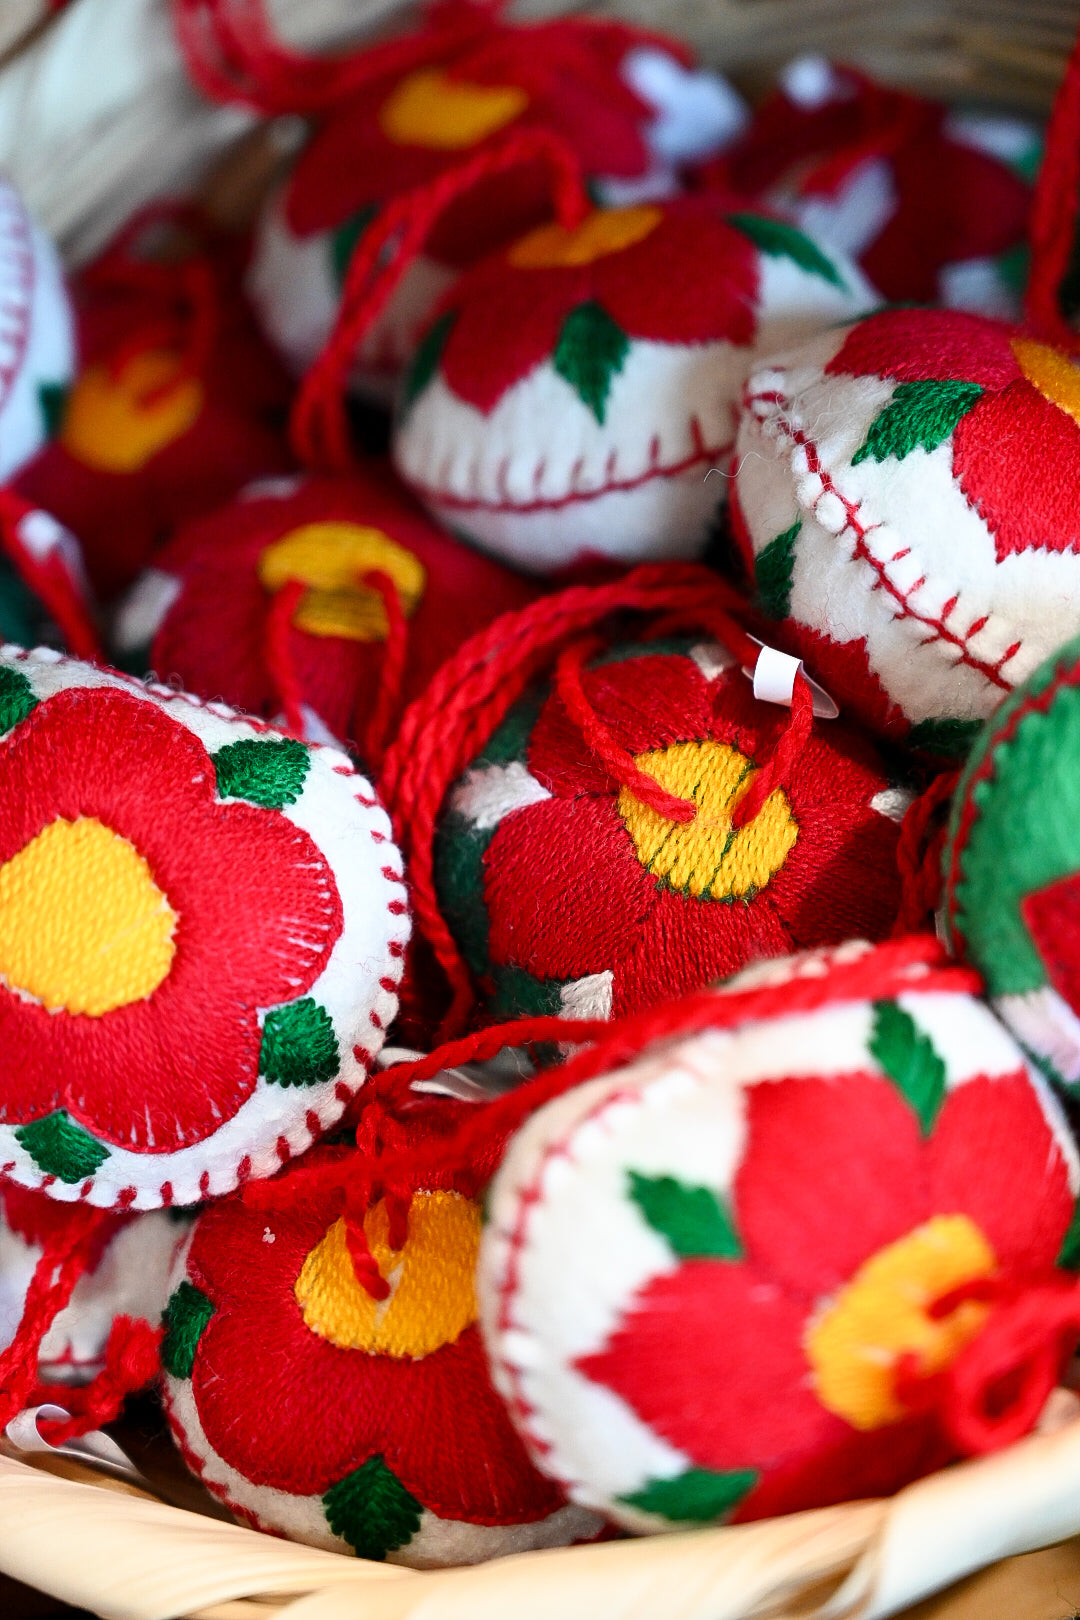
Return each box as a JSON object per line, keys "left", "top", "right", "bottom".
{"left": 18, "top": 217, "right": 295, "bottom": 599}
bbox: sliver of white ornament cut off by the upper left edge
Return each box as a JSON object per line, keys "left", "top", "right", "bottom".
{"left": 0, "top": 178, "right": 74, "bottom": 483}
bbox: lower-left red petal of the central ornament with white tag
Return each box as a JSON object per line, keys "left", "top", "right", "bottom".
{"left": 484, "top": 797, "right": 659, "bottom": 978}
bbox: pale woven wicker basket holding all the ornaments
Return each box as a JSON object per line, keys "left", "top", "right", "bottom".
{"left": 0, "top": 0, "right": 1080, "bottom": 1620}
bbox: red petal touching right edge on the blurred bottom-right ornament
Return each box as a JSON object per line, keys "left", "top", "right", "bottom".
{"left": 926, "top": 1069, "right": 1075, "bottom": 1272}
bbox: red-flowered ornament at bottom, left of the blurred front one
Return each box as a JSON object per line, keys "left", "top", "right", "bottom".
{"left": 164, "top": 1146, "right": 601, "bottom": 1567}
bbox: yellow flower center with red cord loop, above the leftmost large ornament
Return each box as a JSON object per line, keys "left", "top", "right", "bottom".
{"left": 259, "top": 523, "right": 426, "bottom": 642}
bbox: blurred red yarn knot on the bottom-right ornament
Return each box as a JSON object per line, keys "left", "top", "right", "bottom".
{"left": 895, "top": 1272, "right": 1080, "bottom": 1456}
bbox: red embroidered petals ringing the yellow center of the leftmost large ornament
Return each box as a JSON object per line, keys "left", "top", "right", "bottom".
{"left": 0, "top": 689, "right": 342, "bottom": 1153}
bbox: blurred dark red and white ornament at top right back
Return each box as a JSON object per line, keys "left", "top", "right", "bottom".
{"left": 699, "top": 57, "right": 1041, "bottom": 319}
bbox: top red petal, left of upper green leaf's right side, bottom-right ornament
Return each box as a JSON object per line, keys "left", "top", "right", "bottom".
{"left": 735, "top": 1074, "right": 928, "bottom": 1301}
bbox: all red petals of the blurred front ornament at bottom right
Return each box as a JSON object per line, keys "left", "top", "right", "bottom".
{"left": 580, "top": 1074, "right": 1074, "bottom": 1520}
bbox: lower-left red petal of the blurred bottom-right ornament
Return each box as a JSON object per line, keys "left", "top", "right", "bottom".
{"left": 578, "top": 1260, "right": 822, "bottom": 1471}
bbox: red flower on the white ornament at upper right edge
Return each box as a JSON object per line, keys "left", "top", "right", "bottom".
{"left": 827, "top": 309, "right": 1080, "bottom": 562}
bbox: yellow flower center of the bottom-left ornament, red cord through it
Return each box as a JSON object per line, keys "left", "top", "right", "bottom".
{"left": 296, "top": 1192, "right": 479, "bottom": 1359}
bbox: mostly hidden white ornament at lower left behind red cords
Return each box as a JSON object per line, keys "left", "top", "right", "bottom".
{"left": 0, "top": 1183, "right": 189, "bottom": 1383}
